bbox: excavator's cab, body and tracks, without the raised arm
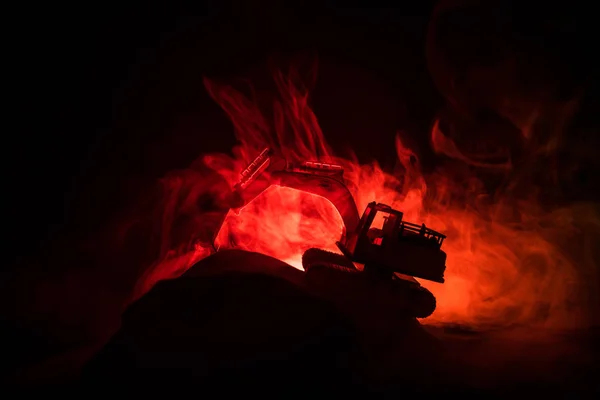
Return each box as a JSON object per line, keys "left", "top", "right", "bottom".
{"left": 302, "top": 202, "right": 446, "bottom": 318}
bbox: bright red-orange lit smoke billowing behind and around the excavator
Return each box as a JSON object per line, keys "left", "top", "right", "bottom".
{"left": 134, "top": 63, "right": 596, "bottom": 327}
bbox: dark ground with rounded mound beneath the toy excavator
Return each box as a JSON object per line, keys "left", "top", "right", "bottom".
{"left": 77, "top": 251, "right": 598, "bottom": 393}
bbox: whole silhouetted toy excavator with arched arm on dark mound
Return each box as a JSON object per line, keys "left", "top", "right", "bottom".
{"left": 219, "top": 148, "right": 446, "bottom": 318}
